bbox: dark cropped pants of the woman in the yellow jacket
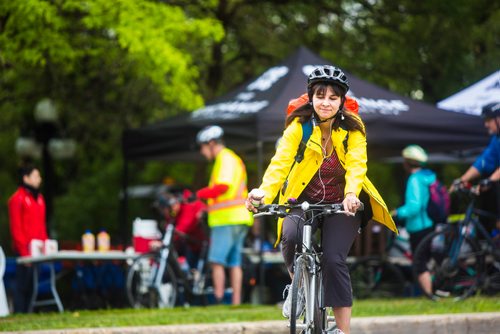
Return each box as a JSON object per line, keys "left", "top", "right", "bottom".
{"left": 281, "top": 209, "right": 361, "bottom": 307}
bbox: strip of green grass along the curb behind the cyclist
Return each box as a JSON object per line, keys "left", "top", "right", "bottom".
{"left": 0, "top": 297, "right": 500, "bottom": 332}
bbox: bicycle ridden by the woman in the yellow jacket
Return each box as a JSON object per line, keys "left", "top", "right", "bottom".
{"left": 254, "top": 200, "right": 363, "bottom": 334}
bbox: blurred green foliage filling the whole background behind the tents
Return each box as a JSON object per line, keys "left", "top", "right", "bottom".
{"left": 0, "top": 0, "right": 500, "bottom": 248}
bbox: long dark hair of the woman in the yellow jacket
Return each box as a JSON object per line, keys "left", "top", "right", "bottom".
{"left": 285, "top": 82, "right": 366, "bottom": 136}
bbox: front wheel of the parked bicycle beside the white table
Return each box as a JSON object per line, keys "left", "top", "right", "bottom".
{"left": 126, "top": 253, "right": 178, "bottom": 308}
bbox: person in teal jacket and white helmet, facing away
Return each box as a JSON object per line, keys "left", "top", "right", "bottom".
{"left": 391, "top": 145, "right": 436, "bottom": 296}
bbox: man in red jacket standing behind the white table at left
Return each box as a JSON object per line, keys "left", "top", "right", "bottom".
{"left": 8, "top": 166, "right": 48, "bottom": 313}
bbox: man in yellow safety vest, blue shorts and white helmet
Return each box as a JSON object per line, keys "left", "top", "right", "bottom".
{"left": 196, "top": 125, "right": 253, "bottom": 305}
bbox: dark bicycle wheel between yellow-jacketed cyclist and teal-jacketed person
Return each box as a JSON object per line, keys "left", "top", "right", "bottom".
{"left": 350, "top": 257, "right": 407, "bottom": 299}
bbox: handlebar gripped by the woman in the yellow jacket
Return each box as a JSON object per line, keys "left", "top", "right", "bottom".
{"left": 253, "top": 201, "right": 364, "bottom": 218}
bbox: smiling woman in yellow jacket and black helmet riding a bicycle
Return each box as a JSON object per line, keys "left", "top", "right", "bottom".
{"left": 246, "top": 65, "right": 396, "bottom": 333}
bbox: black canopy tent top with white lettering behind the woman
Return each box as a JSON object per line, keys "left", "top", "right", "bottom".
{"left": 123, "top": 47, "right": 487, "bottom": 161}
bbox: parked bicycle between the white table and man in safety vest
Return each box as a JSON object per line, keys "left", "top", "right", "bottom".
{"left": 126, "top": 190, "right": 210, "bottom": 308}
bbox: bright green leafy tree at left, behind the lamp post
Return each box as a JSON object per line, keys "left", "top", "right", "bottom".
{"left": 0, "top": 0, "right": 224, "bottom": 250}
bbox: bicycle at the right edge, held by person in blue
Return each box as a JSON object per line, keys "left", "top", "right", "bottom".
{"left": 414, "top": 181, "right": 500, "bottom": 301}
